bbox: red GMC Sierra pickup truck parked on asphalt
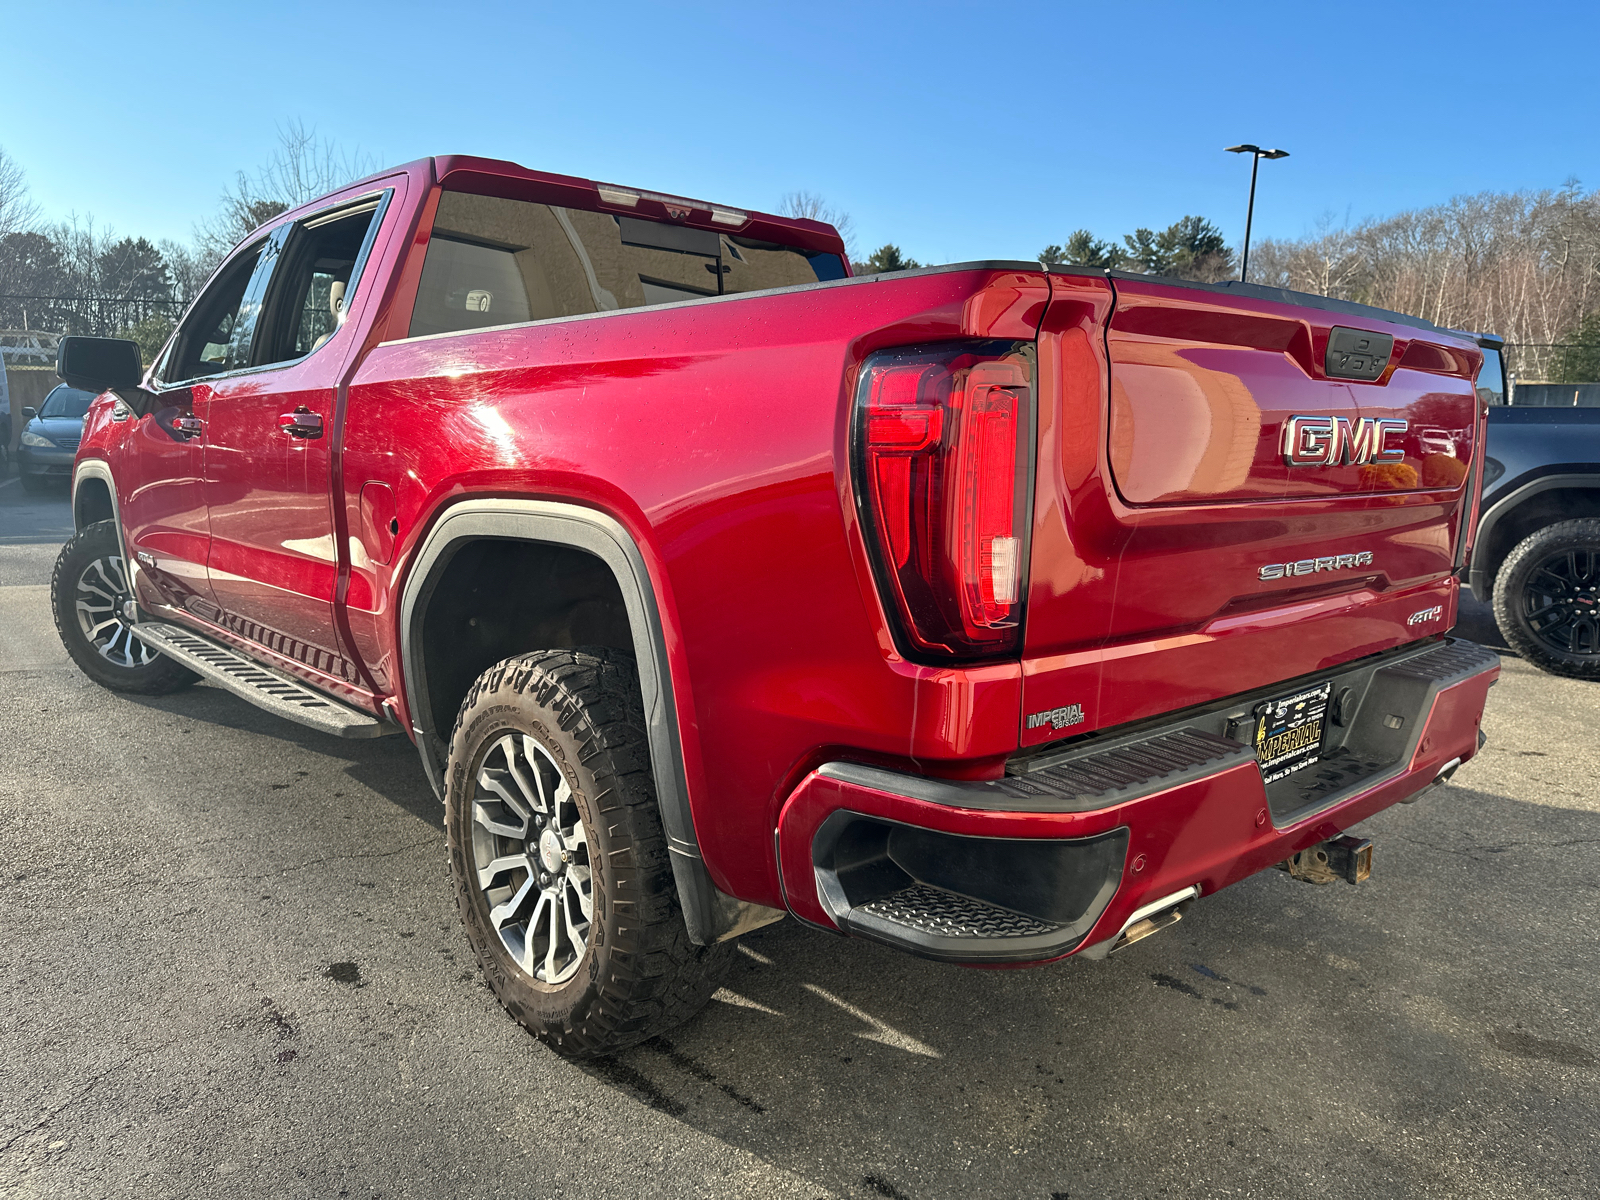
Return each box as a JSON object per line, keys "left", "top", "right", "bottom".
{"left": 54, "top": 157, "right": 1498, "bottom": 1054}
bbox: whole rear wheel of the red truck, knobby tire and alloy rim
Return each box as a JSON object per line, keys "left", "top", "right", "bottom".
{"left": 445, "top": 648, "right": 733, "bottom": 1058}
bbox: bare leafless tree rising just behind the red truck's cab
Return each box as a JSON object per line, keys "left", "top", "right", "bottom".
{"left": 195, "top": 118, "right": 378, "bottom": 274}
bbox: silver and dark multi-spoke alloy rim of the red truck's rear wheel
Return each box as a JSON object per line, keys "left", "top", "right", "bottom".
{"left": 472, "top": 733, "right": 594, "bottom": 987}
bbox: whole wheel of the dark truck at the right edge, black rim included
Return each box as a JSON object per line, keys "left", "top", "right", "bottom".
{"left": 1494, "top": 518, "right": 1600, "bottom": 678}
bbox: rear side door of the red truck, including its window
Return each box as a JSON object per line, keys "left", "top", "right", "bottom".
{"left": 202, "top": 194, "right": 387, "bottom": 685}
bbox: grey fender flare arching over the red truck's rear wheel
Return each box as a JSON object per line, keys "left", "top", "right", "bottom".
{"left": 398, "top": 499, "right": 782, "bottom": 946}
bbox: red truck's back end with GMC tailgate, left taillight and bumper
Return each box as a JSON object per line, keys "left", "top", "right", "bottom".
{"left": 778, "top": 269, "right": 1499, "bottom": 963}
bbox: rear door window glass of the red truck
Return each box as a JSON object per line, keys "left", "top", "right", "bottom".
{"left": 254, "top": 200, "right": 378, "bottom": 366}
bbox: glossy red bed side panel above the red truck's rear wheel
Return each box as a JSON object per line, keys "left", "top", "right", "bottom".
{"left": 344, "top": 270, "right": 1048, "bottom": 904}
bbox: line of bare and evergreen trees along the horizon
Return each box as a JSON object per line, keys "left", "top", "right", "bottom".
{"left": 0, "top": 130, "right": 1600, "bottom": 382}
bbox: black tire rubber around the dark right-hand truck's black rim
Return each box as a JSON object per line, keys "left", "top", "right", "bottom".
{"left": 1494, "top": 517, "right": 1600, "bottom": 680}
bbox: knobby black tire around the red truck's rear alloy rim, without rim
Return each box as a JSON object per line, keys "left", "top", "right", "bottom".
{"left": 445, "top": 648, "right": 733, "bottom": 1058}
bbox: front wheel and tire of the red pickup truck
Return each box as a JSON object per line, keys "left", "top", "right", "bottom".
{"left": 50, "top": 524, "right": 200, "bottom": 696}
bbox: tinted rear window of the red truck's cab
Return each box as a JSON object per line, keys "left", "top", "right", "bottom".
{"left": 411, "top": 192, "right": 845, "bottom": 338}
